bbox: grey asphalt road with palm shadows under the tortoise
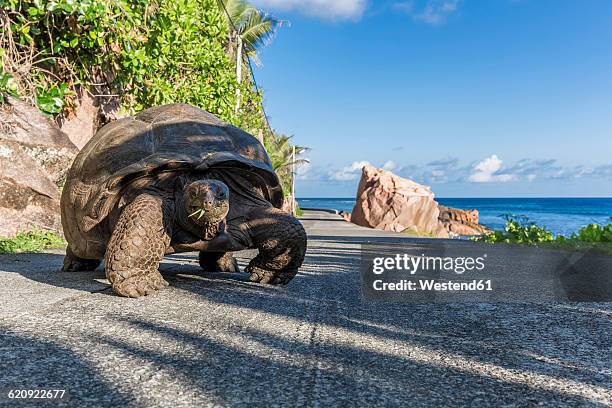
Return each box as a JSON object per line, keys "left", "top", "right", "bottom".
{"left": 0, "top": 212, "right": 612, "bottom": 407}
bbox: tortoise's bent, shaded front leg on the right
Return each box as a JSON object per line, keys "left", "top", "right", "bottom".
{"left": 245, "top": 207, "right": 306, "bottom": 284}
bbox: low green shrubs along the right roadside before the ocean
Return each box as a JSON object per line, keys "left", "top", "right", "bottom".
{"left": 474, "top": 216, "right": 612, "bottom": 252}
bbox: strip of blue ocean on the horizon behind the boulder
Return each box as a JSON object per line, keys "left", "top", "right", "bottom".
{"left": 298, "top": 197, "right": 612, "bottom": 235}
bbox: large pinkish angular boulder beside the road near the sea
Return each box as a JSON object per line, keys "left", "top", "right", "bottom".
{"left": 351, "top": 165, "right": 449, "bottom": 238}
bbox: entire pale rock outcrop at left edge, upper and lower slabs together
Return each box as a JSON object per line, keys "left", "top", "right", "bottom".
{"left": 0, "top": 97, "right": 78, "bottom": 236}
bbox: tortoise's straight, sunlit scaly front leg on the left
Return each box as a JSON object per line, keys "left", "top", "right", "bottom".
{"left": 105, "top": 194, "right": 174, "bottom": 297}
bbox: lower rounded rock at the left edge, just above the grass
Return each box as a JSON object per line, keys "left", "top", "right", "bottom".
{"left": 0, "top": 141, "right": 61, "bottom": 237}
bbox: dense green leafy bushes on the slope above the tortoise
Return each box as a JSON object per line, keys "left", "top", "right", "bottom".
{"left": 0, "top": 0, "right": 263, "bottom": 129}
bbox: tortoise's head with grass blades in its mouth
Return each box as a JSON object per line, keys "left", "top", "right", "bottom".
{"left": 183, "top": 179, "right": 229, "bottom": 236}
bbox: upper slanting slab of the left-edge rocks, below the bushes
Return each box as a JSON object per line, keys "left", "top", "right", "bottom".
{"left": 0, "top": 97, "right": 78, "bottom": 184}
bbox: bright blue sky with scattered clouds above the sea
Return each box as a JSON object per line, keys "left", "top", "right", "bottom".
{"left": 253, "top": 0, "right": 612, "bottom": 197}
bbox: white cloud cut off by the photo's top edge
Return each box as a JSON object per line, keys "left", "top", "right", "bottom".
{"left": 253, "top": 0, "right": 367, "bottom": 20}
